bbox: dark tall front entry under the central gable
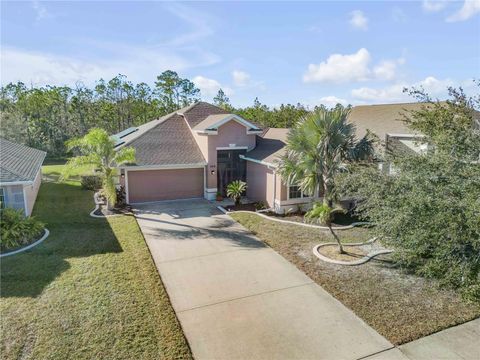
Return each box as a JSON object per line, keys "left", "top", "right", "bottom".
{"left": 217, "top": 150, "right": 247, "bottom": 196}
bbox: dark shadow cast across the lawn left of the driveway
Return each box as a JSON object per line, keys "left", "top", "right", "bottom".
{"left": 0, "top": 182, "right": 122, "bottom": 297}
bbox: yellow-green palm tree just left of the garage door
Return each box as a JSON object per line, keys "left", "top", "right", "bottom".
{"left": 61, "top": 128, "right": 135, "bottom": 208}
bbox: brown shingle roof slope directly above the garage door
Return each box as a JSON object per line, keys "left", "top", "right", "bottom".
{"left": 127, "top": 114, "right": 205, "bottom": 165}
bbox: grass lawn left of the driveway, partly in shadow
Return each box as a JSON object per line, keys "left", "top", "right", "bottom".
{"left": 0, "top": 165, "right": 191, "bottom": 359}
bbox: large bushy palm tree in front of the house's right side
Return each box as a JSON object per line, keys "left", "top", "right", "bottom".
{"left": 279, "top": 107, "right": 374, "bottom": 207}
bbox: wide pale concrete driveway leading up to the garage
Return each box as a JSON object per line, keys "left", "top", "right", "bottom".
{"left": 134, "top": 200, "right": 394, "bottom": 359}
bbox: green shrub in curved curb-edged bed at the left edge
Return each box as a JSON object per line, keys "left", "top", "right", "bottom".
{"left": 0, "top": 208, "right": 44, "bottom": 251}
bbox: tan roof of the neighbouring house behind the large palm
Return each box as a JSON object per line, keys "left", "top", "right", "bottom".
{"left": 348, "top": 103, "right": 425, "bottom": 140}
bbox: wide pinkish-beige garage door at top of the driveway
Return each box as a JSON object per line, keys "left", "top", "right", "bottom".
{"left": 127, "top": 168, "right": 204, "bottom": 203}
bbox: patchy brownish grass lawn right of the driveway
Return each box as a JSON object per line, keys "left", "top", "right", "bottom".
{"left": 232, "top": 213, "right": 480, "bottom": 345}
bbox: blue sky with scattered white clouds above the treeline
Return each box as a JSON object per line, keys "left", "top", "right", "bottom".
{"left": 1, "top": 0, "right": 480, "bottom": 106}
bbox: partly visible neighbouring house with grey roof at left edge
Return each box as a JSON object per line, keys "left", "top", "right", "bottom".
{"left": 0, "top": 138, "right": 46, "bottom": 216}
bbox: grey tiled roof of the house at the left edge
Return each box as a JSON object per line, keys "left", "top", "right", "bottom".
{"left": 0, "top": 138, "right": 47, "bottom": 184}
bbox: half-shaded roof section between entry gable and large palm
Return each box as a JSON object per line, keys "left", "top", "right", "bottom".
{"left": 245, "top": 128, "right": 289, "bottom": 164}
